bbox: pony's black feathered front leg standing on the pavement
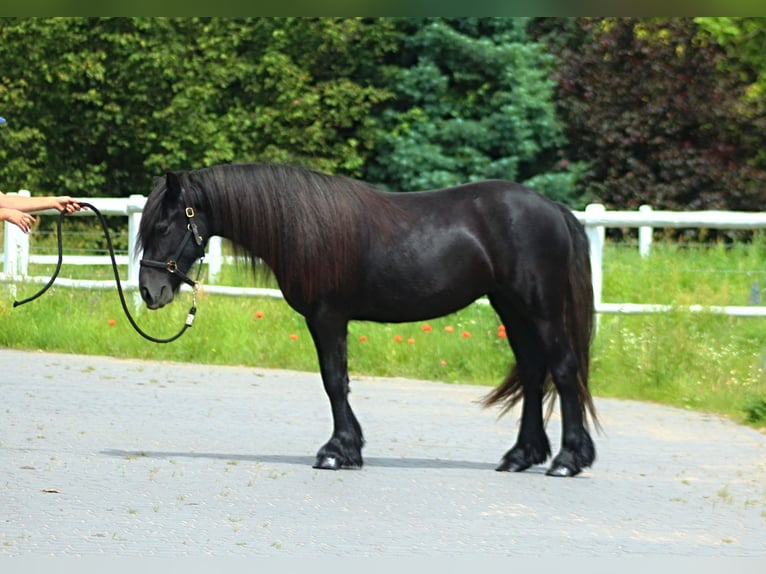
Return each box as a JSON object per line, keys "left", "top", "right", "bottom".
{"left": 306, "top": 315, "right": 364, "bottom": 470}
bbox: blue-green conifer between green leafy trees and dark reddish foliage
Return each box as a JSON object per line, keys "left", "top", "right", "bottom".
{"left": 366, "top": 18, "right": 575, "bottom": 206}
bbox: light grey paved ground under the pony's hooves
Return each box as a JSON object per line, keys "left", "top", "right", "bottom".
{"left": 0, "top": 350, "right": 766, "bottom": 560}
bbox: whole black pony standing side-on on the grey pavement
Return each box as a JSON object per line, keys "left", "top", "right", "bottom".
{"left": 139, "top": 164, "right": 596, "bottom": 476}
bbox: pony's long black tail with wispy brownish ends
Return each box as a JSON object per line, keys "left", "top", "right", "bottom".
{"left": 481, "top": 205, "right": 601, "bottom": 429}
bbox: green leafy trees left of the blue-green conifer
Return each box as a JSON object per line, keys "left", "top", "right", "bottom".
{"left": 0, "top": 18, "right": 391, "bottom": 196}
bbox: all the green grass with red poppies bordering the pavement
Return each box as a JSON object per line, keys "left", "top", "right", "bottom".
{"left": 0, "top": 236, "right": 766, "bottom": 428}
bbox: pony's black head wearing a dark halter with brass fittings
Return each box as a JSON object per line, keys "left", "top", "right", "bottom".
{"left": 138, "top": 173, "right": 210, "bottom": 309}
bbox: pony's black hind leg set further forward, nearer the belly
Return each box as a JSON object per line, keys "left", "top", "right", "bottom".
{"left": 484, "top": 296, "right": 551, "bottom": 472}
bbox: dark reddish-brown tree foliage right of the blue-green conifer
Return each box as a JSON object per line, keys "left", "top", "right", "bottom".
{"left": 557, "top": 18, "right": 766, "bottom": 214}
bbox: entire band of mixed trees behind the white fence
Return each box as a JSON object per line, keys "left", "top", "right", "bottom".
{"left": 0, "top": 18, "right": 766, "bottom": 216}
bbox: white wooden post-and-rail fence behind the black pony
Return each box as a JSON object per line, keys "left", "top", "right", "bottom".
{"left": 0, "top": 194, "right": 766, "bottom": 317}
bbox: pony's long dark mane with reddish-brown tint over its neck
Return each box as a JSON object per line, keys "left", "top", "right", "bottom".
{"left": 164, "top": 164, "right": 403, "bottom": 301}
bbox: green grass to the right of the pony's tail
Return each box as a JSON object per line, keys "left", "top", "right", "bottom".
{"left": 593, "top": 240, "right": 766, "bottom": 428}
